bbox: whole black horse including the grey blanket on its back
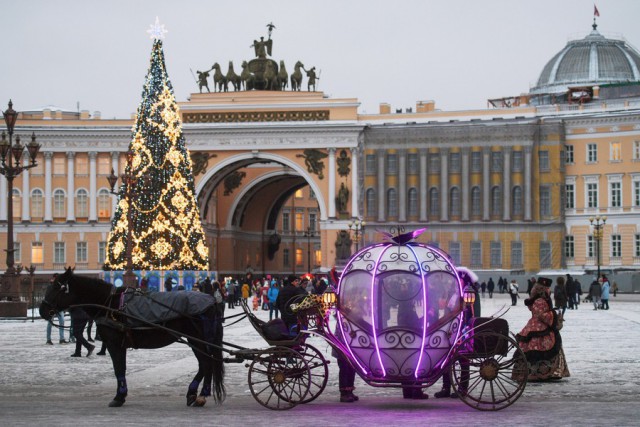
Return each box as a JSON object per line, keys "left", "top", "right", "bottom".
{"left": 40, "top": 267, "right": 225, "bottom": 407}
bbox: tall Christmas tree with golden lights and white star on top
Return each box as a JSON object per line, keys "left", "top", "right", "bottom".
{"left": 104, "top": 19, "right": 208, "bottom": 270}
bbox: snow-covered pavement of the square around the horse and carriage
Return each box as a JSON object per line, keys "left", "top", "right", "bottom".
{"left": 0, "top": 294, "right": 640, "bottom": 427}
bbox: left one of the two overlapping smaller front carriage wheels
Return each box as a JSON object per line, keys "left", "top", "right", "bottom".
{"left": 249, "top": 347, "right": 311, "bottom": 410}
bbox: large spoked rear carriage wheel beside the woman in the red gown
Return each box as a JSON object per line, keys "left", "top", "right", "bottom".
{"left": 451, "top": 332, "right": 528, "bottom": 411}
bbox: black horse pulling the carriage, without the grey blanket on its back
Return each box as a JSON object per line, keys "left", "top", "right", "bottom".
{"left": 40, "top": 267, "right": 225, "bottom": 407}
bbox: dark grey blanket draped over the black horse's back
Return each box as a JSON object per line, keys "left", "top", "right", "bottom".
{"left": 121, "top": 291, "right": 216, "bottom": 326}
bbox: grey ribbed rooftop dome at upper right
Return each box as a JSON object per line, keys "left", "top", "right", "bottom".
{"left": 530, "top": 24, "right": 640, "bottom": 94}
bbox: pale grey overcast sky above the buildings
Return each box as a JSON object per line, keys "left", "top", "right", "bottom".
{"left": 0, "top": 0, "right": 640, "bottom": 119}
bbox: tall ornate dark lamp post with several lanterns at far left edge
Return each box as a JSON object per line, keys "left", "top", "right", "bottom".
{"left": 0, "top": 100, "right": 40, "bottom": 314}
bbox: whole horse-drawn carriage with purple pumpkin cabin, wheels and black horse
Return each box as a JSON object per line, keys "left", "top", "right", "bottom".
{"left": 41, "top": 232, "right": 528, "bottom": 410}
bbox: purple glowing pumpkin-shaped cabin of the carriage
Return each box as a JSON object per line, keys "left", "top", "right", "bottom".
{"left": 335, "top": 241, "right": 464, "bottom": 383}
